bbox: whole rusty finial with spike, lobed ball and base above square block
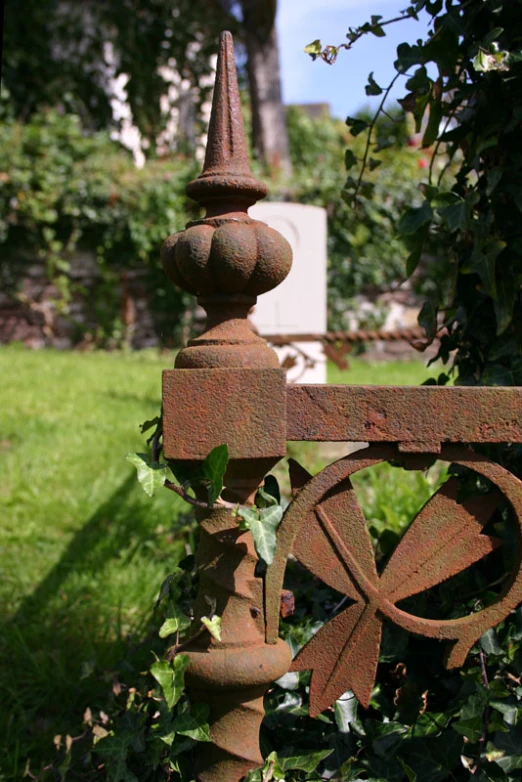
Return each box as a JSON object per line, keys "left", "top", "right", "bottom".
{"left": 162, "top": 33, "right": 292, "bottom": 369}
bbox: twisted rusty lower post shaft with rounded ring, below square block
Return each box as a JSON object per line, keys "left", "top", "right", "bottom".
{"left": 186, "top": 510, "right": 291, "bottom": 782}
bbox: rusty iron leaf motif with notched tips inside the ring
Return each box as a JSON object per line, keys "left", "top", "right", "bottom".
{"left": 292, "top": 462, "right": 501, "bottom": 716}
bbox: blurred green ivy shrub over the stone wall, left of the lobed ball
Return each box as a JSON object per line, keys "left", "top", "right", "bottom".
{"left": 0, "top": 109, "right": 196, "bottom": 343}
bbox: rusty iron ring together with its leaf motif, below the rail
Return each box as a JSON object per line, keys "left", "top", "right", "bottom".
{"left": 266, "top": 445, "right": 522, "bottom": 716}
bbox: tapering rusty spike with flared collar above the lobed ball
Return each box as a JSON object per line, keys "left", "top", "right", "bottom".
{"left": 187, "top": 32, "right": 267, "bottom": 216}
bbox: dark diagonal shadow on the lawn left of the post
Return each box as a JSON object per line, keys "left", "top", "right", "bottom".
{"left": 0, "top": 476, "right": 187, "bottom": 782}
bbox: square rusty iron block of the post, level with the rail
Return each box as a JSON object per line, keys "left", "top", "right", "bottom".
{"left": 163, "top": 369, "right": 286, "bottom": 460}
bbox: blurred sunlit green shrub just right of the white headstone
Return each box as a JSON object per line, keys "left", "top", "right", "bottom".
{"left": 280, "top": 107, "right": 424, "bottom": 329}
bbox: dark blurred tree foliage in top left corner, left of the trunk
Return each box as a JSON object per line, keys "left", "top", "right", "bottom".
{"left": 2, "top": 0, "right": 228, "bottom": 145}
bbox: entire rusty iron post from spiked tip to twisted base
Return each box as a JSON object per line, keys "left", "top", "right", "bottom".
{"left": 162, "top": 33, "right": 291, "bottom": 782}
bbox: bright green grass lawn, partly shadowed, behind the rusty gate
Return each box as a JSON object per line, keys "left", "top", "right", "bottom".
{"left": 0, "top": 347, "right": 430, "bottom": 779}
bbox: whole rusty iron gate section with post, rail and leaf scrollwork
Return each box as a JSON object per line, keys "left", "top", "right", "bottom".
{"left": 159, "top": 33, "right": 522, "bottom": 782}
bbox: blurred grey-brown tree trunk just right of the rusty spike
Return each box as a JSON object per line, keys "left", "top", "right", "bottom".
{"left": 242, "top": 0, "right": 292, "bottom": 175}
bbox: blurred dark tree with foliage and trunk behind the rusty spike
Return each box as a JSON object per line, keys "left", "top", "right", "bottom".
{"left": 3, "top": 0, "right": 289, "bottom": 168}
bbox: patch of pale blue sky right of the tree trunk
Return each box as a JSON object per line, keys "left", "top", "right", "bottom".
{"left": 277, "top": 0, "right": 427, "bottom": 119}
